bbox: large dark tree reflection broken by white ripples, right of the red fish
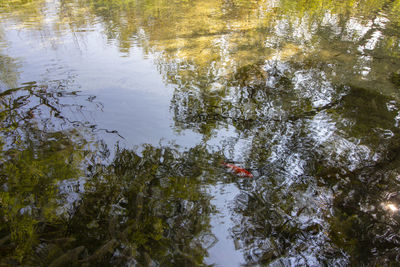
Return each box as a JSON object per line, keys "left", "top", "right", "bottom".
{"left": 172, "top": 57, "right": 400, "bottom": 265}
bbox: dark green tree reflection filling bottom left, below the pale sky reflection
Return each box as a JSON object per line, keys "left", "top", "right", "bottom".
{"left": 1, "top": 142, "right": 220, "bottom": 265}
